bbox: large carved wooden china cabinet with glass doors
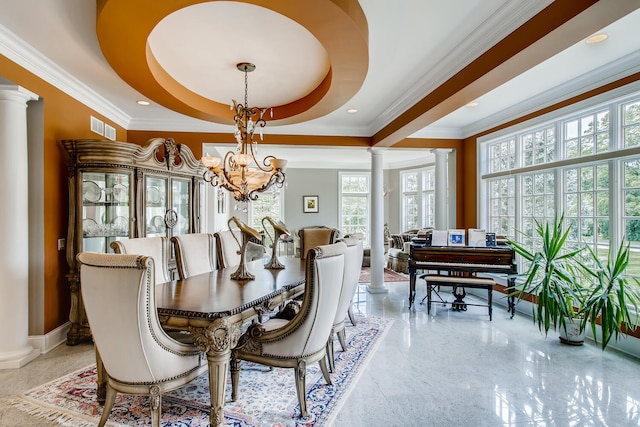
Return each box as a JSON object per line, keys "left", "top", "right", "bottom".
{"left": 62, "top": 138, "right": 205, "bottom": 345}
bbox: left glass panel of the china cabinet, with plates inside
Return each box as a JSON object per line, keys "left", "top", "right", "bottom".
{"left": 80, "top": 172, "right": 132, "bottom": 253}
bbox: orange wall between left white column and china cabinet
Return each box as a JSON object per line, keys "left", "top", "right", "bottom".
{"left": 0, "top": 55, "right": 126, "bottom": 333}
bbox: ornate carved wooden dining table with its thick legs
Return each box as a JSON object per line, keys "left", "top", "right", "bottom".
{"left": 96, "top": 256, "right": 306, "bottom": 426}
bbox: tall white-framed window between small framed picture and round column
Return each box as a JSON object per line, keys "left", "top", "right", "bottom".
{"left": 339, "top": 172, "right": 370, "bottom": 245}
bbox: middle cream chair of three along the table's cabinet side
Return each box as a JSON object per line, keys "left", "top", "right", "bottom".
{"left": 171, "top": 233, "right": 215, "bottom": 279}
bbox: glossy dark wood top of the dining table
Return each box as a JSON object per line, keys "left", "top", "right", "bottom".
{"left": 155, "top": 256, "right": 305, "bottom": 319}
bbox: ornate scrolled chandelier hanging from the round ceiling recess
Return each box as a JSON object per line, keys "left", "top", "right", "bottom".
{"left": 201, "top": 62, "right": 287, "bottom": 202}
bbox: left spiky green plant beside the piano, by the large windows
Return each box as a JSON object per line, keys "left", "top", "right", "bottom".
{"left": 508, "top": 215, "right": 584, "bottom": 342}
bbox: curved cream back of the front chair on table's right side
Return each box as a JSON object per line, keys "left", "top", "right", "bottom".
{"left": 262, "top": 242, "right": 346, "bottom": 358}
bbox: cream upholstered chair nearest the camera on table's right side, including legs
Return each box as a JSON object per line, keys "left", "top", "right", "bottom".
{"left": 231, "top": 242, "right": 346, "bottom": 417}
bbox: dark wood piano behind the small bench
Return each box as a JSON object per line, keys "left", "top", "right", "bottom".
{"left": 409, "top": 243, "right": 518, "bottom": 317}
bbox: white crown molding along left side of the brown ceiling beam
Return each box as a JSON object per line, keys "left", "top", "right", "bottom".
{"left": 371, "top": 0, "right": 553, "bottom": 134}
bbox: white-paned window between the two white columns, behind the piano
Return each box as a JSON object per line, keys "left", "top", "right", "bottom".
{"left": 400, "top": 168, "right": 435, "bottom": 231}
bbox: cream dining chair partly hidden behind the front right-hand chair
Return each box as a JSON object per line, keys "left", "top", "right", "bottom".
{"left": 327, "top": 237, "right": 364, "bottom": 372}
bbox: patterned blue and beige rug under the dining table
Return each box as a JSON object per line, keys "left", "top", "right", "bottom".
{"left": 10, "top": 316, "right": 393, "bottom": 427}
